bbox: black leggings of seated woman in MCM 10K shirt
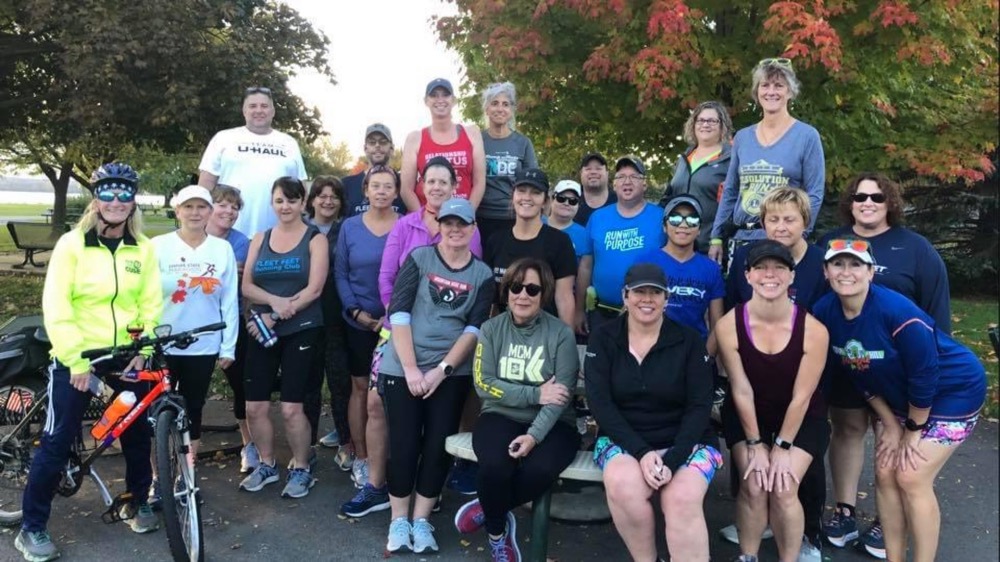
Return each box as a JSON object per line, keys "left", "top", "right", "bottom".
{"left": 472, "top": 413, "right": 580, "bottom": 536}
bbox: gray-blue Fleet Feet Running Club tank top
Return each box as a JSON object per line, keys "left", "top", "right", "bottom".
{"left": 251, "top": 225, "right": 323, "bottom": 336}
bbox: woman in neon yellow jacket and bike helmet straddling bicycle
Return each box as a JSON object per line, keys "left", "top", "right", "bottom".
{"left": 14, "top": 162, "right": 163, "bottom": 561}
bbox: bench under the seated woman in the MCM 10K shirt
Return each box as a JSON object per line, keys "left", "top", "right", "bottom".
{"left": 444, "top": 345, "right": 603, "bottom": 562}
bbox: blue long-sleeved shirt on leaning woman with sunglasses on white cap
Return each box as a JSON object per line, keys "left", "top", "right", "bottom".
{"left": 813, "top": 284, "right": 986, "bottom": 421}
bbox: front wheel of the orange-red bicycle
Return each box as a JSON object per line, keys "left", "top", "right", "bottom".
{"left": 156, "top": 408, "right": 205, "bottom": 562}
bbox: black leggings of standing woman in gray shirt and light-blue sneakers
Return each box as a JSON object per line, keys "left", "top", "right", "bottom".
{"left": 386, "top": 373, "right": 472, "bottom": 498}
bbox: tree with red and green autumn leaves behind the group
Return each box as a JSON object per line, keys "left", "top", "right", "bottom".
{"left": 437, "top": 0, "right": 1000, "bottom": 186}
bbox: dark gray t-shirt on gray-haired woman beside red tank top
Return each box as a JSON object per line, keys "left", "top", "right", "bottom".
{"left": 477, "top": 129, "right": 538, "bottom": 219}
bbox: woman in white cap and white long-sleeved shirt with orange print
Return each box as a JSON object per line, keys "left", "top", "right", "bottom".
{"left": 153, "top": 185, "right": 239, "bottom": 470}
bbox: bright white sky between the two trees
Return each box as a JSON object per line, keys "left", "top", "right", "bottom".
{"left": 279, "top": 0, "right": 464, "bottom": 157}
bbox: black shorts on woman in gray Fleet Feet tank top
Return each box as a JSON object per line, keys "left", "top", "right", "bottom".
{"left": 244, "top": 328, "right": 323, "bottom": 404}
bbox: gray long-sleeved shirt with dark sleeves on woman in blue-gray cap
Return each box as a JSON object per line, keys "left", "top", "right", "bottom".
{"left": 379, "top": 246, "right": 495, "bottom": 377}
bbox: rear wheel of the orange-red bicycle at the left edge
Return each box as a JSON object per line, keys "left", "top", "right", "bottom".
{"left": 0, "top": 379, "right": 47, "bottom": 527}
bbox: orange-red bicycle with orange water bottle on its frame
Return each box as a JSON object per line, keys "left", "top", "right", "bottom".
{"left": 0, "top": 322, "right": 226, "bottom": 562}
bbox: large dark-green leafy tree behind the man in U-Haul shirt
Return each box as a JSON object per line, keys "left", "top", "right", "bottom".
{"left": 0, "top": 0, "right": 333, "bottom": 221}
